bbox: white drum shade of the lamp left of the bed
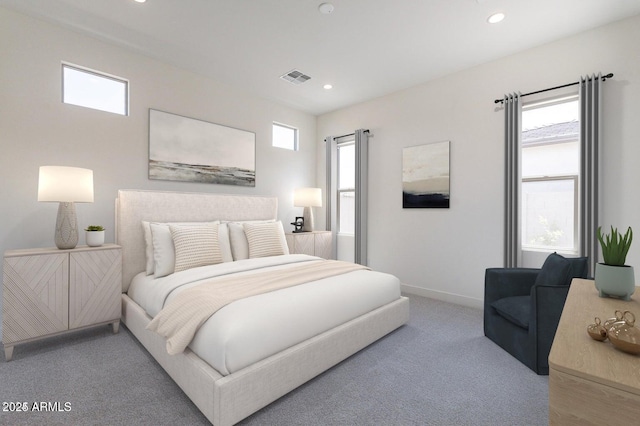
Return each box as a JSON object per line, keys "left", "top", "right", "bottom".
{"left": 38, "top": 166, "right": 93, "bottom": 203}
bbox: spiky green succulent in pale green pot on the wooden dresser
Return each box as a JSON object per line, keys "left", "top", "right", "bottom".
{"left": 595, "top": 226, "right": 636, "bottom": 300}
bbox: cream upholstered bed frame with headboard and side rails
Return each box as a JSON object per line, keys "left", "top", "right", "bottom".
{"left": 116, "top": 190, "right": 409, "bottom": 426}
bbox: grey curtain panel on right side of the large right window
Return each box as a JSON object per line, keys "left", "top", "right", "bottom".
{"left": 579, "top": 74, "right": 602, "bottom": 276}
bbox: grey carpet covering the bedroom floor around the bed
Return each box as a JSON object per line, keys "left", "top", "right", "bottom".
{"left": 0, "top": 296, "right": 548, "bottom": 426}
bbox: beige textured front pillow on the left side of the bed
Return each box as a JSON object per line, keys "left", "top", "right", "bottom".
{"left": 169, "top": 223, "right": 222, "bottom": 272}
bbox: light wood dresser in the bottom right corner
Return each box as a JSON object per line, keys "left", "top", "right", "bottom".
{"left": 549, "top": 279, "right": 640, "bottom": 426}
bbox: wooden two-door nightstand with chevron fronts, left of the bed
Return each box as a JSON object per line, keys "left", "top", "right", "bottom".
{"left": 2, "top": 244, "right": 122, "bottom": 361}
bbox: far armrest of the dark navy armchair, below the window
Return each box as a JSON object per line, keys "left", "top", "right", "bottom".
{"left": 484, "top": 268, "right": 540, "bottom": 306}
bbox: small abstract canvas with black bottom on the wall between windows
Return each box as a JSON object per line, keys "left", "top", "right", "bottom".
{"left": 402, "top": 141, "right": 449, "bottom": 208}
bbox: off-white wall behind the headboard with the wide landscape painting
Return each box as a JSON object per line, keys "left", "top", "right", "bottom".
{"left": 0, "top": 8, "right": 316, "bottom": 342}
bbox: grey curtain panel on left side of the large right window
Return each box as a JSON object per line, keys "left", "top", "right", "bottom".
{"left": 503, "top": 93, "right": 522, "bottom": 268}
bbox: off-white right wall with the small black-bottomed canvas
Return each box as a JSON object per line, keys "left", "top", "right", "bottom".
{"left": 317, "top": 16, "right": 640, "bottom": 306}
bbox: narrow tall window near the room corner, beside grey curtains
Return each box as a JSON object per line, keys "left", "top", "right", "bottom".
{"left": 338, "top": 142, "right": 356, "bottom": 235}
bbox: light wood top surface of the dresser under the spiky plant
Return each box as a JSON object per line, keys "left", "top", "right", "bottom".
{"left": 549, "top": 279, "right": 640, "bottom": 397}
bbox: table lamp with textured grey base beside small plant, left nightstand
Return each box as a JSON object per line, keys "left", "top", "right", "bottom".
{"left": 38, "top": 166, "right": 93, "bottom": 249}
